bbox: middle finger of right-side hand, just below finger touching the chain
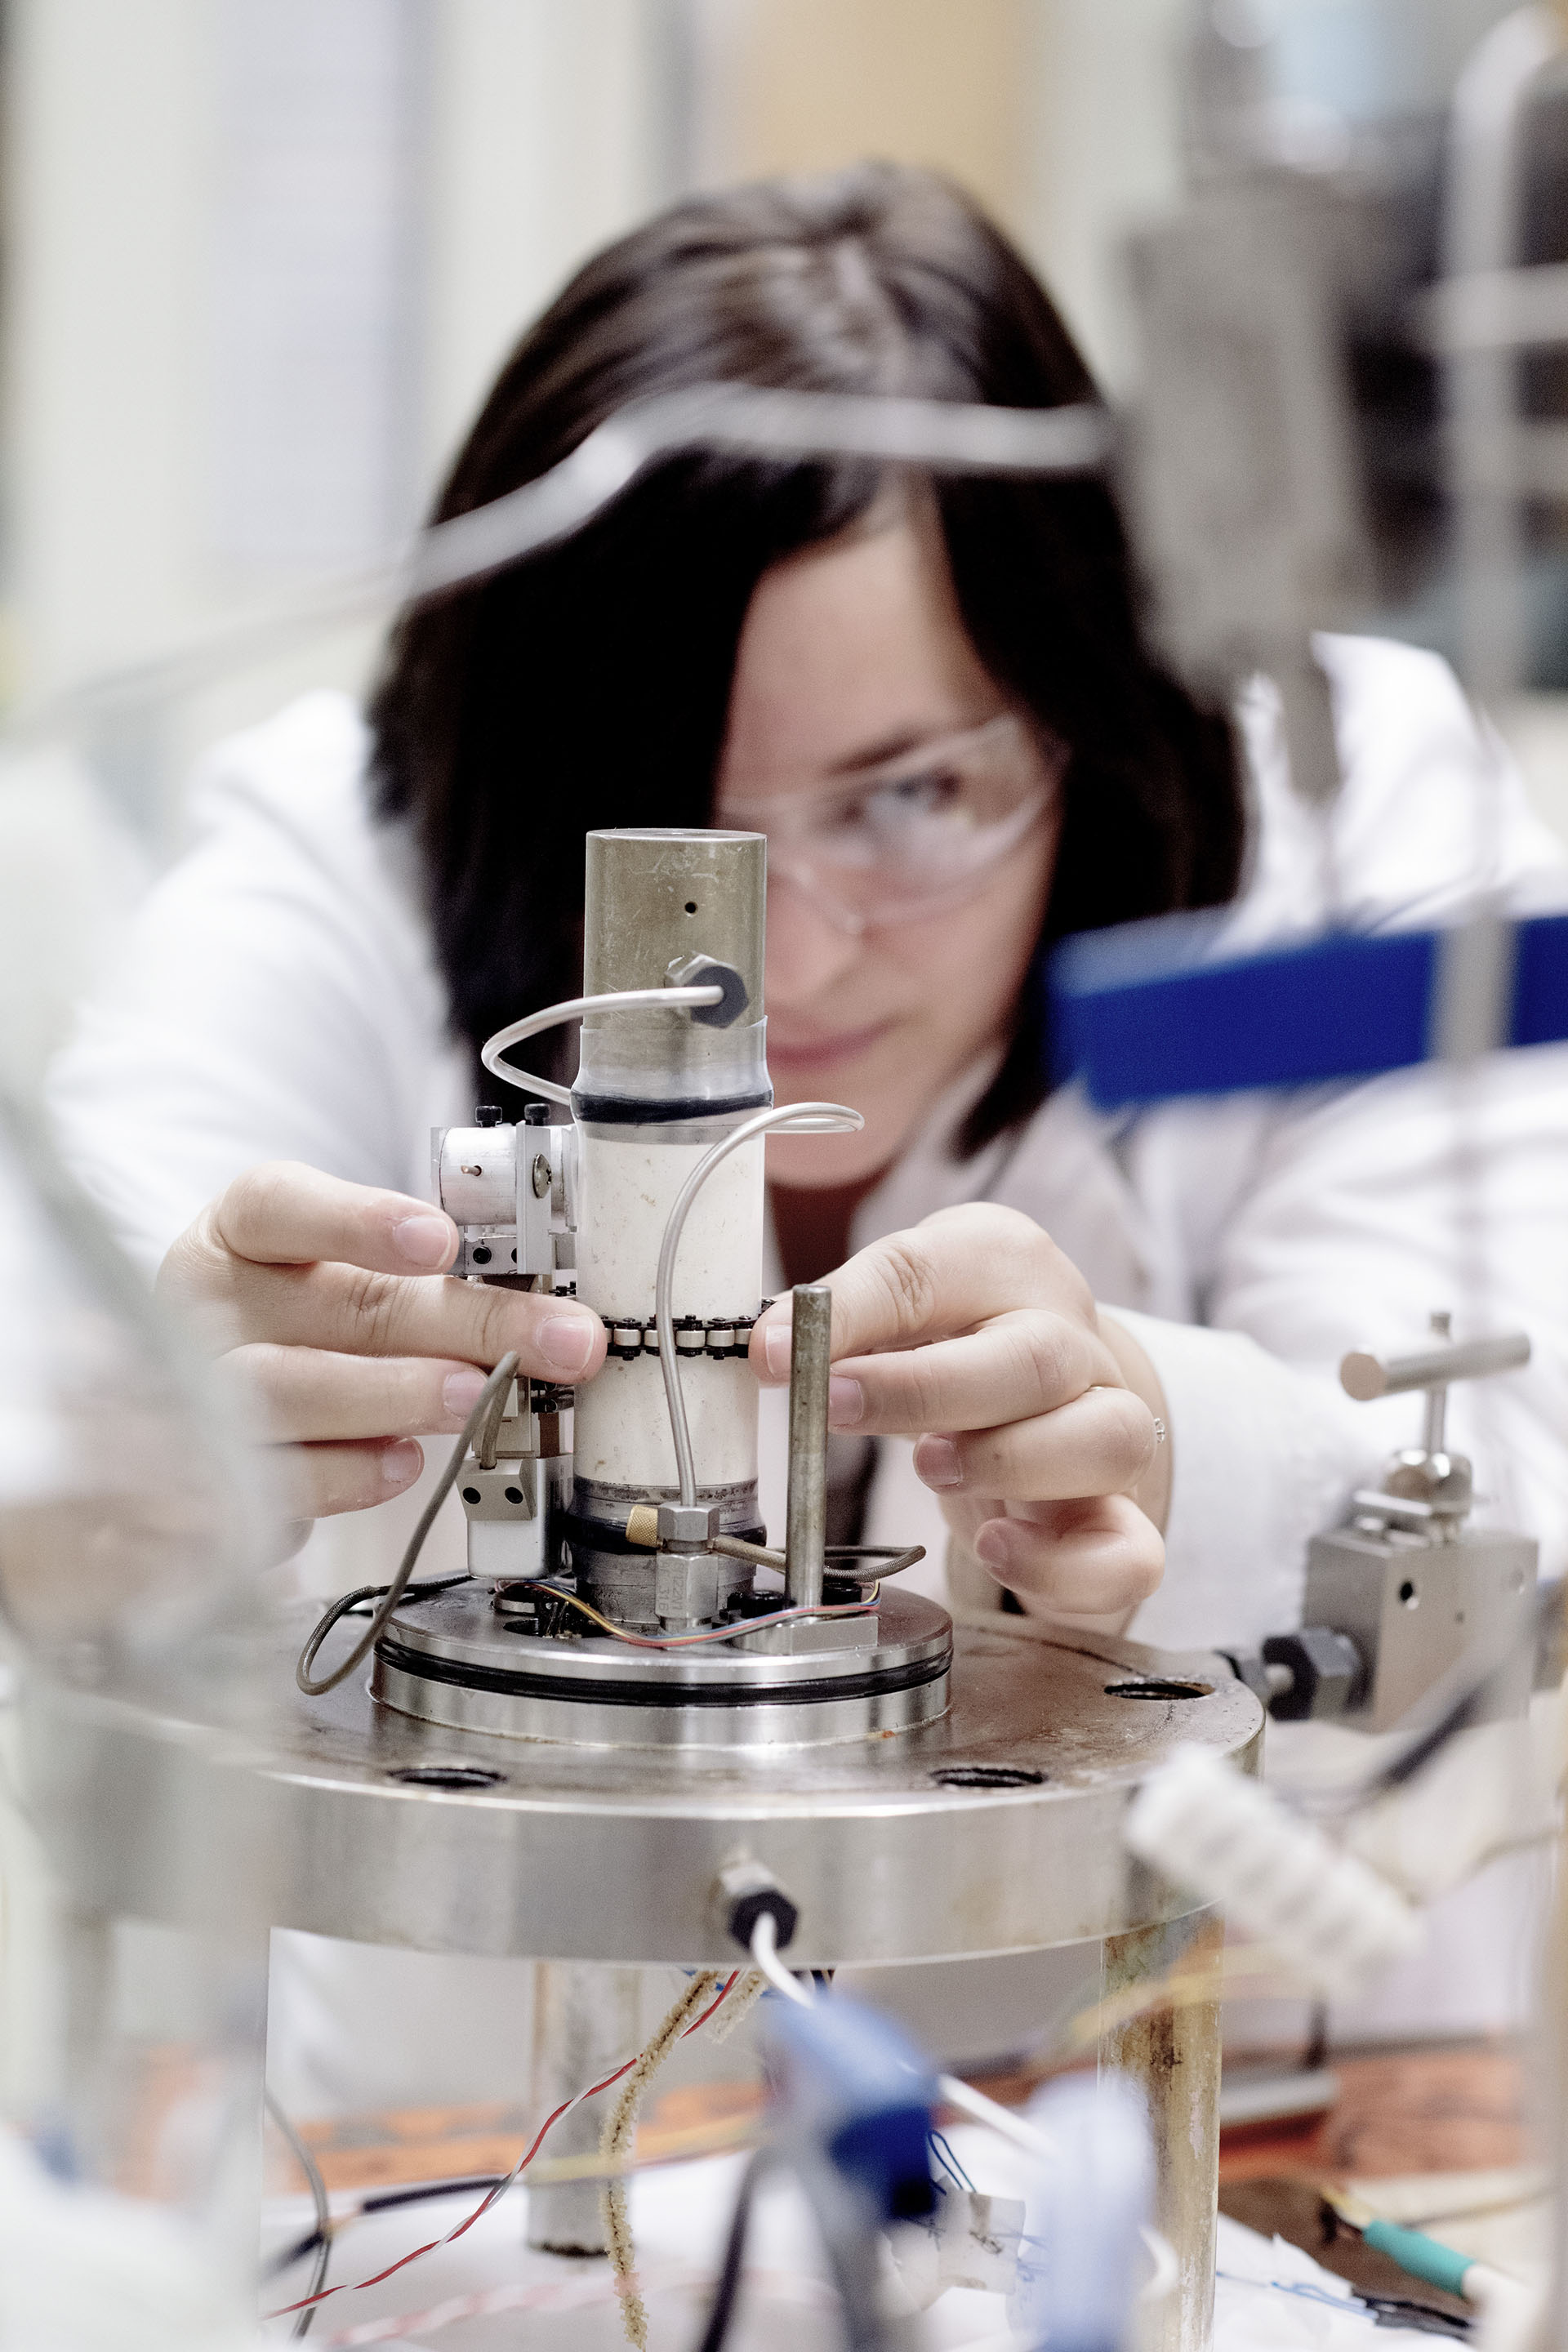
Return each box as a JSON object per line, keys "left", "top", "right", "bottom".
{"left": 827, "top": 1307, "right": 1121, "bottom": 1437}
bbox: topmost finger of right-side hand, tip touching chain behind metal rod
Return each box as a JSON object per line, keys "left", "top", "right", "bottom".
{"left": 752, "top": 1202, "right": 1095, "bottom": 1381}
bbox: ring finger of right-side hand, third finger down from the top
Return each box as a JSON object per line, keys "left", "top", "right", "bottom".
{"left": 915, "top": 1388, "right": 1154, "bottom": 1503}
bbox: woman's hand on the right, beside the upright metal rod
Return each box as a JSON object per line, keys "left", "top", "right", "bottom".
{"left": 752, "top": 1202, "right": 1171, "bottom": 1628}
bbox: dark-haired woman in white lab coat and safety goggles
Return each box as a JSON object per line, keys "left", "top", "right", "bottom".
{"left": 56, "top": 167, "right": 1568, "bottom": 2060}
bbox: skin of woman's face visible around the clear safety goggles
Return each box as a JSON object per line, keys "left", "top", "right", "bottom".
{"left": 717, "top": 513, "right": 1060, "bottom": 1186}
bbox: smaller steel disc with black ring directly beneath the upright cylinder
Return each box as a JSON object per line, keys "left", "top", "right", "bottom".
{"left": 372, "top": 1583, "right": 952, "bottom": 1753}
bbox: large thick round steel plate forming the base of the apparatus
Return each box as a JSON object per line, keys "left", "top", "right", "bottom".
{"left": 24, "top": 1611, "right": 1263, "bottom": 1967}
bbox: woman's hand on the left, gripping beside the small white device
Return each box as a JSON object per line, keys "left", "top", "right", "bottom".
{"left": 158, "top": 1160, "right": 604, "bottom": 1519}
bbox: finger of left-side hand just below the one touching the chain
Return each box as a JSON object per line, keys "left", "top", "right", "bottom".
{"left": 214, "top": 1345, "right": 484, "bottom": 1444}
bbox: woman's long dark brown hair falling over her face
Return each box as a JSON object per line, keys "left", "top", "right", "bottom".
{"left": 372, "top": 165, "right": 1244, "bottom": 1147}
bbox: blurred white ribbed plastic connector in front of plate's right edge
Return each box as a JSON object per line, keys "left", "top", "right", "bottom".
{"left": 1124, "top": 1748, "right": 1424, "bottom": 1999}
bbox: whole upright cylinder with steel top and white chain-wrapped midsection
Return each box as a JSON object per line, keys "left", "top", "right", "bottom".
{"left": 571, "top": 831, "right": 773, "bottom": 1625}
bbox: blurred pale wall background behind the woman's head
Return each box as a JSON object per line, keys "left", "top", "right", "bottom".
{"left": 0, "top": 0, "right": 1568, "bottom": 880}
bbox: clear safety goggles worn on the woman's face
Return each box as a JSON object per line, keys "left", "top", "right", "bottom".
{"left": 715, "top": 710, "right": 1067, "bottom": 933}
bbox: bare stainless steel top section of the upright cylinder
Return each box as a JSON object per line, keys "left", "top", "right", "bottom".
{"left": 571, "top": 826, "right": 773, "bottom": 1127}
